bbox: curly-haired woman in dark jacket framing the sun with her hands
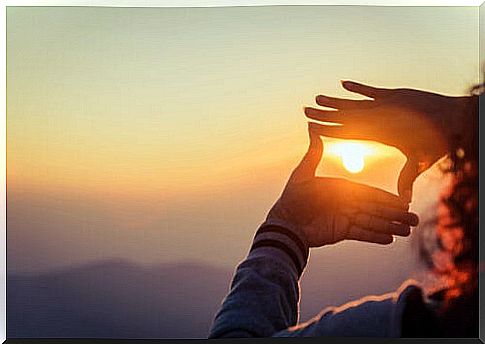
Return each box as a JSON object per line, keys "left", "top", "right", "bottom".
{"left": 209, "top": 82, "right": 478, "bottom": 338}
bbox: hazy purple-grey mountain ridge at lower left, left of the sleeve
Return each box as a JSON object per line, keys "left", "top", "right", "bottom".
{"left": 7, "top": 261, "right": 232, "bottom": 338}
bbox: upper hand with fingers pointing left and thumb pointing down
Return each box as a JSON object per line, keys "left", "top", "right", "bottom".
{"left": 305, "top": 81, "right": 470, "bottom": 202}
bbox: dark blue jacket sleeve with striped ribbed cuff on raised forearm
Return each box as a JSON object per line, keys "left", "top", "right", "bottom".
{"left": 209, "top": 221, "right": 309, "bottom": 338}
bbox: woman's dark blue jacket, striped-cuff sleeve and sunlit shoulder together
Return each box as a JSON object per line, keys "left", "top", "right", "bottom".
{"left": 209, "top": 222, "right": 432, "bottom": 338}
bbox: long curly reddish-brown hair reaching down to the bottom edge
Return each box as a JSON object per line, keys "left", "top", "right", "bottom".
{"left": 420, "top": 84, "right": 485, "bottom": 337}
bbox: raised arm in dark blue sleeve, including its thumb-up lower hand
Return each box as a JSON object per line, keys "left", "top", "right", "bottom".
{"left": 209, "top": 129, "right": 418, "bottom": 338}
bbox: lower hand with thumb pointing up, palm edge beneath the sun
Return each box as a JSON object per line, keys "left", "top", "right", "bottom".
{"left": 267, "top": 125, "right": 418, "bottom": 247}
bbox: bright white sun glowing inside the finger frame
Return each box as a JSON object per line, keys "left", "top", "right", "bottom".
{"left": 326, "top": 142, "right": 371, "bottom": 173}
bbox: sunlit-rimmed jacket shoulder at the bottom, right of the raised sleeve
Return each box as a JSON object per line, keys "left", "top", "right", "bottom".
{"left": 280, "top": 280, "right": 423, "bottom": 337}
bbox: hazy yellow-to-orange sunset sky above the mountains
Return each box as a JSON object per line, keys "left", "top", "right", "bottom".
{"left": 7, "top": 6, "right": 479, "bottom": 271}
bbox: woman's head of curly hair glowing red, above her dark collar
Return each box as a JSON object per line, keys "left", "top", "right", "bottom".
{"left": 435, "top": 86, "right": 476, "bottom": 300}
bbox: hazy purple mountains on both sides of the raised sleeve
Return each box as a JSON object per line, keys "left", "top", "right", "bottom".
{"left": 7, "top": 245, "right": 411, "bottom": 338}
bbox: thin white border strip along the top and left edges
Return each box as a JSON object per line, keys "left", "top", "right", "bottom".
{"left": 0, "top": 0, "right": 485, "bottom": 342}
